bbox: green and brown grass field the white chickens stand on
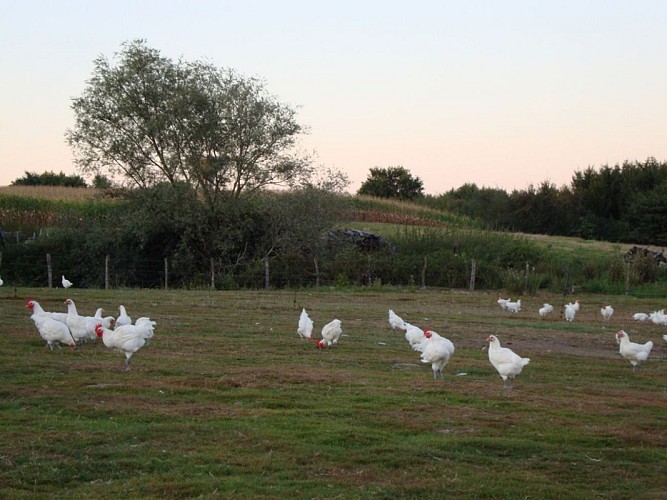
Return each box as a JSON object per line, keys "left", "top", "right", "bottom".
{"left": 0, "top": 286, "right": 667, "bottom": 498}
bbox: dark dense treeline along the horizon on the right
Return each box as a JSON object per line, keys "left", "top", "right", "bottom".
{"left": 424, "top": 158, "right": 667, "bottom": 245}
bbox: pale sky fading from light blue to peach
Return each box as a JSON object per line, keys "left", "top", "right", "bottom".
{"left": 0, "top": 0, "right": 667, "bottom": 195}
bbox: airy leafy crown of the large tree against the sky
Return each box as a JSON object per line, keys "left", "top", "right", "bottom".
{"left": 66, "top": 40, "right": 313, "bottom": 205}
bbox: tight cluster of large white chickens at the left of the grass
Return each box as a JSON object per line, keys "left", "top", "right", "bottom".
{"left": 26, "top": 296, "right": 157, "bottom": 371}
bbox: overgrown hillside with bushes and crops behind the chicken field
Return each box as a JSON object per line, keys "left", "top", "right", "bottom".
{"left": 0, "top": 187, "right": 667, "bottom": 296}
